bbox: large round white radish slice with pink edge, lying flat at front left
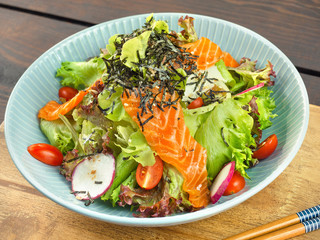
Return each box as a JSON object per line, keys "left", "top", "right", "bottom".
{"left": 72, "top": 153, "right": 115, "bottom": 200}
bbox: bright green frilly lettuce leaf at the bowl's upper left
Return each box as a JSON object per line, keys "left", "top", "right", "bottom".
{"left": 56, "top": 57, "right": 105, "bottom": 90}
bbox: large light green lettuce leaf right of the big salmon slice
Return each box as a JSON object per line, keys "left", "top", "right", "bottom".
{"left": 195, "top": 98, "right": 256, "bottom": 178}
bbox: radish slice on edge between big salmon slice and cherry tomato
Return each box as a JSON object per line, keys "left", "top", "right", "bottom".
{"left": 210, "top": 162, "right": 235, "bottom": 204}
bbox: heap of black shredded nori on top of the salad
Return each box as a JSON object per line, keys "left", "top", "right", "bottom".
{"left": 100, "top": 22, "right": 196, "bottom": 131}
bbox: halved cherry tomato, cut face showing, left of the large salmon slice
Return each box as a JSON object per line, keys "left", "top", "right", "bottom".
{"left": 136, "top": 156, "right": 163, "bottom": 190}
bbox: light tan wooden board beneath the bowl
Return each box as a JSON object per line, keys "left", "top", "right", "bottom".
{"left": 0, "top": 105, "right": 320, "bottom": 240}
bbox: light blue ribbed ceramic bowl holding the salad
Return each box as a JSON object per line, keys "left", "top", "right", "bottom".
{"left": 5, "top": 13, "right": 309, "bottom": 227}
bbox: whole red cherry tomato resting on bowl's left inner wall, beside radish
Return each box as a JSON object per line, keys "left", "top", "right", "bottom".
{"left": 28, "top": 143, "right": 63, "bottom": 166}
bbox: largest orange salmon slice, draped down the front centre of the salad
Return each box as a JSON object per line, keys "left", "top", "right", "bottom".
{"left": 121, "top": 90, "right": 209, "bottom": 208}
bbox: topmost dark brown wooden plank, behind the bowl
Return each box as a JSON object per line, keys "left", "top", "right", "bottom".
{"left": 0, "top": 0, "right": 320, "bottom": 72}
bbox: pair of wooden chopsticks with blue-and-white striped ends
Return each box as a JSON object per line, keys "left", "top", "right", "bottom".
{"left": 225, "top": 205, "right": 320, "bottom": 240}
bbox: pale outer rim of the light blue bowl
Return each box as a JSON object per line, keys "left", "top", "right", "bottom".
{"left": 4, "top": 12, "right": 309, "bottom": 227}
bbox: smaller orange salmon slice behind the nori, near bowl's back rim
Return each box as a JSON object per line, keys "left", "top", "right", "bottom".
{"left": 181, "top": 37, "right": 239, "bottom": 70}
